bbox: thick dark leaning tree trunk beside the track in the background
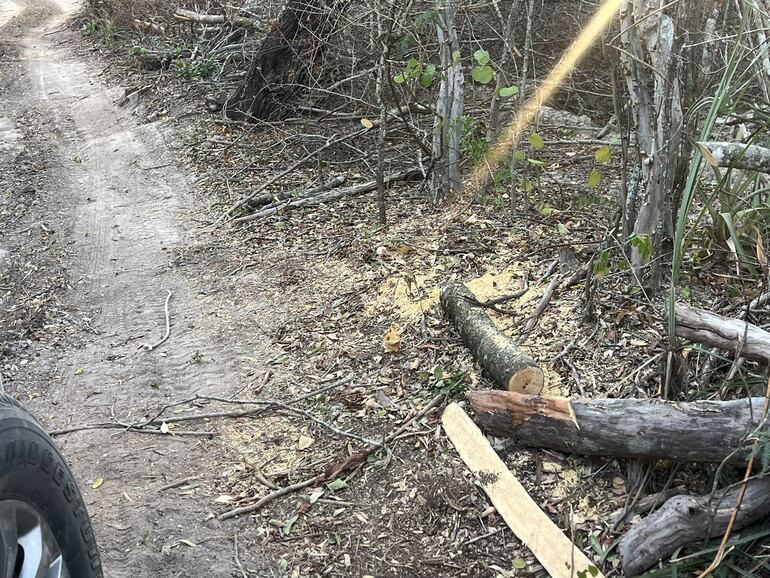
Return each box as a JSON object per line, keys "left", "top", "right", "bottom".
{"left": 225, "top": 0, "right": 342, "bottom": 121}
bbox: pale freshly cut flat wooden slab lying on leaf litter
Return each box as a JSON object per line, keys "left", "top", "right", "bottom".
{"left": 441, "top": 403, "right": 603, "bottom": 578}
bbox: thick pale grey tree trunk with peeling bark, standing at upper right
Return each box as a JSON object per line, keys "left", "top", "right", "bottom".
{"left": 620, "top": 0, "right": 713, "bottom": 288}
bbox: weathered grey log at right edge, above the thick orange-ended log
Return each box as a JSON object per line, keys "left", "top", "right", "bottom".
{"left": 676, "top": 303, "right": 770, "bottom": 362}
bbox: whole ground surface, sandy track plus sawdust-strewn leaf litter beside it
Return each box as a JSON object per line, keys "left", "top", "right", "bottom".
{"left": 0, "top": 0, "right": 756, "bottom": 577}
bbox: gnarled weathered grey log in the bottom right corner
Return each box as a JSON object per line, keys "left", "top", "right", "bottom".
{"left": 620, "top": 478, "right": 770, "bottom": 576}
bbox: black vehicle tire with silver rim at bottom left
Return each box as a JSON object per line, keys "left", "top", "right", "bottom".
{"left": 0, "top": 393, "right": 103, "bottom": 578}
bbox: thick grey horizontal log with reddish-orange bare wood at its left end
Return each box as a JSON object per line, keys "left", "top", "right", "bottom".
{"left": 468, "top": 390, "right": 764, "bottom": 463}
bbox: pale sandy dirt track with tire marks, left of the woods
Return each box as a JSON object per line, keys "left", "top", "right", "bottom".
{"left": 0, "top": 0, "right": 272, "bottom": 577}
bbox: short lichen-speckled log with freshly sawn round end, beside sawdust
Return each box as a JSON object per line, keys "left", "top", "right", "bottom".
{"left": 441, "top": 283, "right": 544, "bottom": 394}
